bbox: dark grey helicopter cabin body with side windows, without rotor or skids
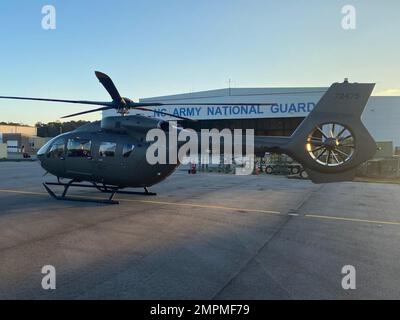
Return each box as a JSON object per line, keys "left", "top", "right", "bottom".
{"left": 38, "top": 122, "right": 179, "bottom": 187}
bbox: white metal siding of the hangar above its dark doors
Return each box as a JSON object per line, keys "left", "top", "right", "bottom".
{"left": 103, "top": 87, "right": 400, "bottom": 147}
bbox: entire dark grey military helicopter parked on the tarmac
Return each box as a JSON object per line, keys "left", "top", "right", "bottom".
{"left": 0, "top": 71, "right": 377, "bottom": 204}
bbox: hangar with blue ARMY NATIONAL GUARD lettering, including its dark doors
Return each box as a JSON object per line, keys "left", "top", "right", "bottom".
{"left": 103, "top": 87, "right": 400, "bottom": 150}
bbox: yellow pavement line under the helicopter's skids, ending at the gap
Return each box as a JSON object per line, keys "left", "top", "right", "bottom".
{"left": 0, "top": 189, "right": 282, "bottom": 215}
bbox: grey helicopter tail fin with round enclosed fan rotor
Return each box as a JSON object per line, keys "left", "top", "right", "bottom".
{"left": 285, "top": 81, "right": 376, "bottom": 183}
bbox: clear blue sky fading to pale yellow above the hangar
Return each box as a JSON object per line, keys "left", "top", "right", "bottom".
{"left": 0, "top": 0, "right": 400, "bottom": 124}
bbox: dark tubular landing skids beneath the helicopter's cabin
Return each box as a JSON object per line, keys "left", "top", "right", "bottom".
{"left": 43, "top": 180, "right": 157, "bottom": 204}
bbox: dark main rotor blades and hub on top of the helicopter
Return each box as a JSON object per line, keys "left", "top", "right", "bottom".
{"left": 0, "top": 71, "right": 276, "bottom": 121}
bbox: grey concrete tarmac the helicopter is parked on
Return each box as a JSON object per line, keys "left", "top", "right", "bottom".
{"left": 0, "top": 162, "right": 400, "bottom": 299}
